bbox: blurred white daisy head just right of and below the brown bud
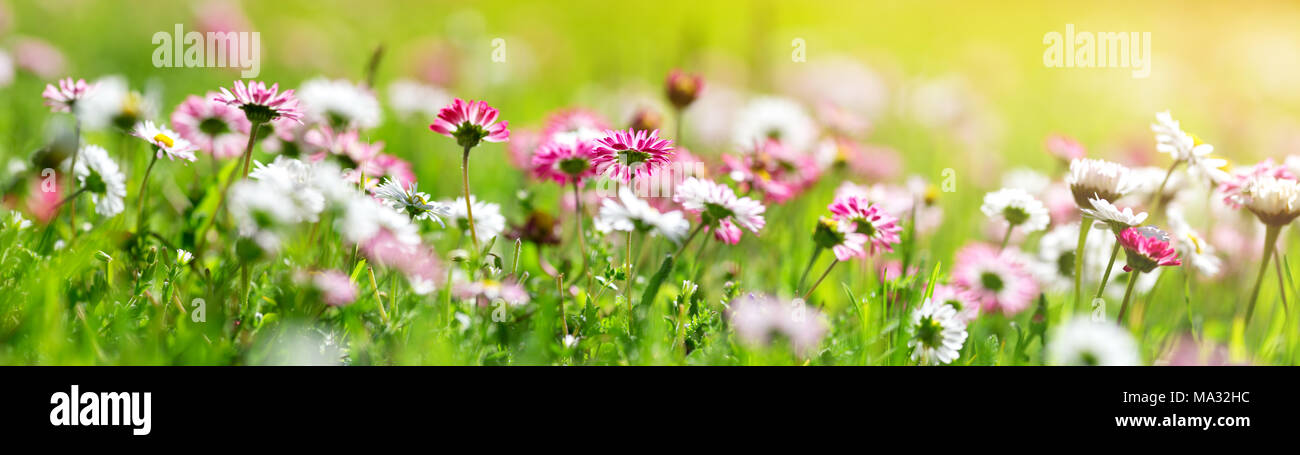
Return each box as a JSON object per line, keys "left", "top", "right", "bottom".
{"left": 732, "top": 96, "right": 816, "bottom": 152}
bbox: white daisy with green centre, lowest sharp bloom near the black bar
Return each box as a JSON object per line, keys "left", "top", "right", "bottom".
{"left": 907, "top": 299, "right": 967, "bottom": 365}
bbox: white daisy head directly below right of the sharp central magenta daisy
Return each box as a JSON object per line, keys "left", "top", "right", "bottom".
{"left": 672, "top": 177, "right": 767, "bottom": 247}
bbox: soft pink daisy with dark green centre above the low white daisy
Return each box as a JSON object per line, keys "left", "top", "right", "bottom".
{"left": 953, "top": 243, "right": 1039, "bottom": 316}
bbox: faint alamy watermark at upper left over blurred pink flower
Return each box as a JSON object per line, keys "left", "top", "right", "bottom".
{"left": 153, "top": 23, "right": 261, "bottom": 78}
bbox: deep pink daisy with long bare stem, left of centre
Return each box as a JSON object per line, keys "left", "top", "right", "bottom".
{"left": 429, "top": 98, "right": 510, "bottom": 251}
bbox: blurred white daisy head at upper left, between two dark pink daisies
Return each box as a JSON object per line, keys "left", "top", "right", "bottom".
{"left": 296, "top": 78, "right": 382, "bottom": 129}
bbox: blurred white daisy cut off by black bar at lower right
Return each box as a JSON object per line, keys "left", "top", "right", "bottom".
{"left": 1047, "top": 317, "right": 1141, "bottom": 365}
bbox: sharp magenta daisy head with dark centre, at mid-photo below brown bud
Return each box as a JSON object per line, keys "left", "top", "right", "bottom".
{"left": 593, "top": 129, "right": 672, "bottom": 183}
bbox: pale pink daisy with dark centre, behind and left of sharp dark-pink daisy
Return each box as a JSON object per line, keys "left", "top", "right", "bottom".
{"left": 172, "top": 92, "right": 252, "bottom": 159}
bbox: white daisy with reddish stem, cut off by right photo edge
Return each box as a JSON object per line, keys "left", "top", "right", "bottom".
{"left": 1238, "top": 177, "right": 1300, "bottom": 321}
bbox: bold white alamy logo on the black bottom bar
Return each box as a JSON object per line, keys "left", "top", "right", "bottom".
{"left": 49, "top": 385, "right": 152, "bottom": 436}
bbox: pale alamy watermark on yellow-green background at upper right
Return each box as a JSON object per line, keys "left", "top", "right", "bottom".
{"left": 1043, "top": 23, "right": 1151, "bottom": 79}
